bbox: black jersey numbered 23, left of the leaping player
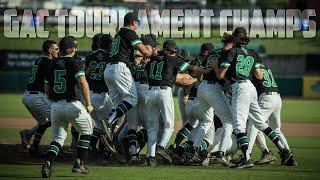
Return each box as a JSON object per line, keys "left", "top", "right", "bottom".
{"left": 85, "top": 49, "right": 109, "bottom": 92}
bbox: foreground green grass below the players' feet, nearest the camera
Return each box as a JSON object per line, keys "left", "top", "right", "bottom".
{"left": 0, "top": 137, "right": 320, "bottom": 180}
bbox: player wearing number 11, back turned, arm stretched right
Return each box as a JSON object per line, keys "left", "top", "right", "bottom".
{"left": 146, "top": 40, "right": 203, "bottom": 166}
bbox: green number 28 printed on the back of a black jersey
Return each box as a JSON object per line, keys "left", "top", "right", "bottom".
{"left": 236, "top": 55, "right": 254, "bottom": 77}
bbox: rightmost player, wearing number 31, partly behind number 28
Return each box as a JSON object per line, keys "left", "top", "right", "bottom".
{"left": 247, "top": 63, "right": 297, "bottom": 165}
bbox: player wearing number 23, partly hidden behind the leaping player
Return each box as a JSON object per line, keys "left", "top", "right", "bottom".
{"left": 85, "top": 34, "right": 113, "bottom": 151}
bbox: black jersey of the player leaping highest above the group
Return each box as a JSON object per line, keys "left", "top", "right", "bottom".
{"left": 110, "top": 28, "right": 142, "bottom": 67}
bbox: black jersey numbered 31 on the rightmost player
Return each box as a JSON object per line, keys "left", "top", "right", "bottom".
{"left": 252, "top": 65, "right": 279, "bottom": 95}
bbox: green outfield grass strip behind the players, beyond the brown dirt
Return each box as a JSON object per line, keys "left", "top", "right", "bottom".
{"left": 0, "top": 94, "right": 320, "bottom": 123}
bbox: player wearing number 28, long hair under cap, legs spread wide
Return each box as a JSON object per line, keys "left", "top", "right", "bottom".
{"left": 216, "top": 27, "right": 292, "bottom": 168}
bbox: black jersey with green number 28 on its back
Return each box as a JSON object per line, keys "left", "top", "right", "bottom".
{"left": 221, "top": 46, "right": 260, "bottom": 82}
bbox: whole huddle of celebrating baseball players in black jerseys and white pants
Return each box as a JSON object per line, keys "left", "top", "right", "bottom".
{"left": 20, "top": 13, "right": 297, "bottom": 177}
